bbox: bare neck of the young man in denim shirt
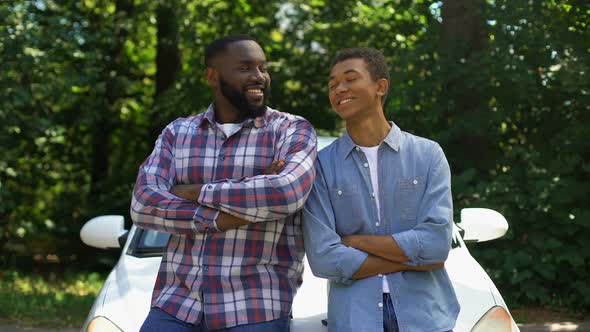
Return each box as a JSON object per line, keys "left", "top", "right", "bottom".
{"left": 346, "top": 111, "right": 391, "bottom": 146}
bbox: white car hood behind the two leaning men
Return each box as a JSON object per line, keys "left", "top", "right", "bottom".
{"left": 91, "top": 247, "right": 505, "bottom": 332}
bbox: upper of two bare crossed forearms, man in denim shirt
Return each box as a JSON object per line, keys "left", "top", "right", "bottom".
{"left": 342, "top": 235, "right": 408, "bottom": 263}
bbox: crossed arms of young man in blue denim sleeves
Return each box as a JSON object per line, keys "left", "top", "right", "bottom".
{"left": 303, "top": 145, "right": 452, "bottom": 284}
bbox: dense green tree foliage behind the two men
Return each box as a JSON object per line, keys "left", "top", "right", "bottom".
{"left": 0, "top": 0, "right": 590, "bottom": 311}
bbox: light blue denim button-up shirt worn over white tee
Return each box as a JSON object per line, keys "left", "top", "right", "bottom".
{"left": 303, "top": 123, "right": 459, "bottom": 332}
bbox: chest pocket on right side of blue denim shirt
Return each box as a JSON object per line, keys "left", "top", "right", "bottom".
{"left": 398, "top": 176, "right": 426, "bottom": 226}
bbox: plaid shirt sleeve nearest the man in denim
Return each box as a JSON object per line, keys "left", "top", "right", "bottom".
{"left": 198, "top": 118, "right": 317, "bottom": 222}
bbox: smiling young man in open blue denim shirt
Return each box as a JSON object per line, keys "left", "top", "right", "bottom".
{"left": 303, "top": 48, "right": 459, "bottom": 332}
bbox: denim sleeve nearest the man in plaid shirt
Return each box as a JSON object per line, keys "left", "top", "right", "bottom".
{"left": 303, "top": 160, "right": 368, "bottom": 284}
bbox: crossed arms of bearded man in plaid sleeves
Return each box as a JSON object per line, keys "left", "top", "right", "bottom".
{"left": 131, "top": 120, "right": 317, "bottom": 234}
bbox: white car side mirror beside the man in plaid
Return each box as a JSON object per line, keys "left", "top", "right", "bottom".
{"left": 80, "top": 215, "right": 127, "bottom": 249}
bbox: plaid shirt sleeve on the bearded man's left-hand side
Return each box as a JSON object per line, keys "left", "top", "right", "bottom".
{"left": 131, "top": 124, "right": 219, "bottom": 234}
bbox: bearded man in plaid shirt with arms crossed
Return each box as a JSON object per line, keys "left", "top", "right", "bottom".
{"left": 131, "top": 35, "right": 317, "bottom": 332}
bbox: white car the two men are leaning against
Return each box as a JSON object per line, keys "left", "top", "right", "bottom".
{"left": 80, "top": 138, "right": 519, "bottom": 332}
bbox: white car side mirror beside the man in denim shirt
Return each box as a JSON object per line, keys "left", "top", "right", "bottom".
{"left": 458, "top": 208, "right": 508, "bottom": 243}
